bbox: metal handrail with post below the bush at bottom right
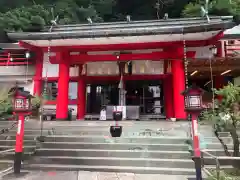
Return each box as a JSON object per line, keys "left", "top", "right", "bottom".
{"left": 201, "top": 150, "right": 240, "bottom": 180}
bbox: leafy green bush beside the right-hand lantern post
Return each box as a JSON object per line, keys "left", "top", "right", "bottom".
{"left": 204, "top": 83, "right": 240, "bottom": 167}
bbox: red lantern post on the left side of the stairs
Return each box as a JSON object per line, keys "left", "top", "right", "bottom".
{"left": 12, "top": 88, "right": 33, "bottom": 175}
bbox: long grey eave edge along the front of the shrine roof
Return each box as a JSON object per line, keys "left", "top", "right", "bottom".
{"left": 8, "top": 20, "right": 234, "bottom": 40}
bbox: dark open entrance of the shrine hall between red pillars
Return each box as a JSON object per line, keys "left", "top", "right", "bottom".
{"left": 86, "top": 80, "right": 165, "bottom": 116}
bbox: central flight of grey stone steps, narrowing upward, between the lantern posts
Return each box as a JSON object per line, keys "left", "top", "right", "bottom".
{"left": 24, "top": 121, "right": 199, "bottom": 175}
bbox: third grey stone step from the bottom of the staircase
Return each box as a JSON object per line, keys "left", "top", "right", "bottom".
{"left": 36, "top": 148, "right": 191, "bottom": 159}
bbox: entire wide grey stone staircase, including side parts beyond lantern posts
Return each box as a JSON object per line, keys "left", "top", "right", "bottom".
{"left": 0, "top": 121, "right": 236, "bottom": 176}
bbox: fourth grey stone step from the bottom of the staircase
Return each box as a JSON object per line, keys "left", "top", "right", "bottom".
{"left": 42, "top": 142, "right": 188, "bottom": 151}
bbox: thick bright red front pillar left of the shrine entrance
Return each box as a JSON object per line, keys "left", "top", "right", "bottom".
{"left": 56, "top": 53, "right": 69, "bottom": 120}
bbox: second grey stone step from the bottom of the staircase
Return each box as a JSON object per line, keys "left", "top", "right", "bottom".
{"left": 30, "top": 156, "right": 194, "bottom": 168}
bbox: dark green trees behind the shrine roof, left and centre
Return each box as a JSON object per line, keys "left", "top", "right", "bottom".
{"left": 0, "top": 0, "right": 199, "bottom": 31}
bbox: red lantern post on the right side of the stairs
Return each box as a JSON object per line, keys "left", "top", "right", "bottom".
{"left": 182, "top": 85, "right": 204, "bottom": 180}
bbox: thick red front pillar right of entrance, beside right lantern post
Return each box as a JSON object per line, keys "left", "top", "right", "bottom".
{"left": 171, "top": 48, "right": 187, "bottom": 119}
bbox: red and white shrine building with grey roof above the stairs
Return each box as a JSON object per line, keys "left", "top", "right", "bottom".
{"left": 0, "top": 17, "right": 239, "bottom": 120}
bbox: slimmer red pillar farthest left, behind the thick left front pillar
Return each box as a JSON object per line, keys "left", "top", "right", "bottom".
{"left": 33, "top": 50, "right": 43, "bottom": 96}
